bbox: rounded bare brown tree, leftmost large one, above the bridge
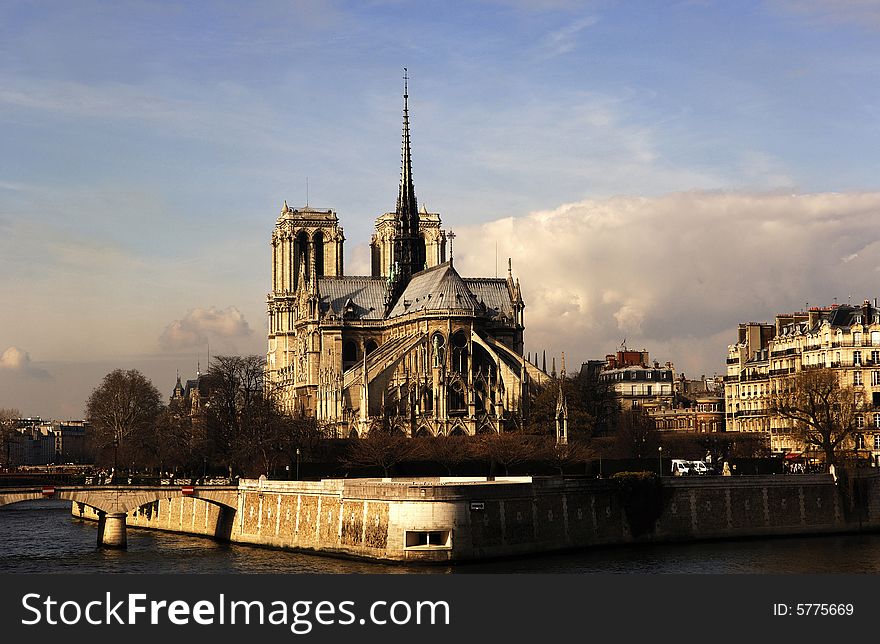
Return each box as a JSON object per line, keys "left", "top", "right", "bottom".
{"left": 86, "top": 369, "right": 162, "bottom": 469}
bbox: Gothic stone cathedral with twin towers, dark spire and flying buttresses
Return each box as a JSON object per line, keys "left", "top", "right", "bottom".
{"left": 267, "top": 74, "right": 549, "bottom": 438}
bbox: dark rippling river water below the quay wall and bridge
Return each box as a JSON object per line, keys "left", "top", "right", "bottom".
{"left": 0, "top": 501, "right": 880, "bottom": 574}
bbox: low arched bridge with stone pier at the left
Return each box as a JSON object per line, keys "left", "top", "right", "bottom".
{"left": 0, "top": 485, "right": 238, "bottom": 548}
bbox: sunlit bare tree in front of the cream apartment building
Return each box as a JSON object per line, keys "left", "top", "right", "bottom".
{"left": 770, "top": 368, "right": 862, "bottom": 466}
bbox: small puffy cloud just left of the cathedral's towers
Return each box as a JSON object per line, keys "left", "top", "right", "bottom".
{"left": 159, "top": 306, "right": 253, "bottom": 351}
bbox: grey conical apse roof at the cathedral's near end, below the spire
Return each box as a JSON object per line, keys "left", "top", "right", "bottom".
{"left": 388, "top": 262, "right": 481, "bottom": 318}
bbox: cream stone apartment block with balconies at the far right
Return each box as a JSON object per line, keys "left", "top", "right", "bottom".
{"left": 724, "top": 300, "right": 880, "bottom": 461}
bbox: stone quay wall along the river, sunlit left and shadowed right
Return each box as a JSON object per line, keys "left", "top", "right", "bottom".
{"left": 73, "top": 473, "right": 880, "bottom": 563}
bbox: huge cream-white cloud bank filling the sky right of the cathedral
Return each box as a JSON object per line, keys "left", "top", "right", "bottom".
{"left": 455, "top": 191, "right": 880, "bottom": 374}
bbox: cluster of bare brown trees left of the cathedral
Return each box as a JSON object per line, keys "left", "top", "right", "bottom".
{"left": 86, "top": 356, "right": 319, "bottom": 475}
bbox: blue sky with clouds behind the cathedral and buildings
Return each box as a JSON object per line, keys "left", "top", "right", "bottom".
{"left": 0, "top": 0, "right": 880, "bottom": 419}
